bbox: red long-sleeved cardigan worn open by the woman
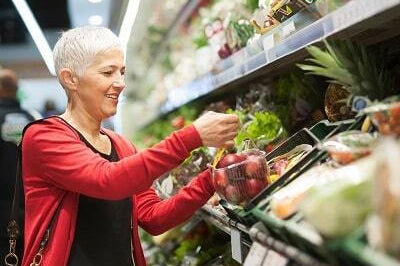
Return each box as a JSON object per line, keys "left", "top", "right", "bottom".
{"left": 22, "top": 117, "right": 214, "bottom": 266}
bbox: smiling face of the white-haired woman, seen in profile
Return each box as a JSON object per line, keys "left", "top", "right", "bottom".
{"left": 77, "top": 48, "right": 125, "bottom": 120}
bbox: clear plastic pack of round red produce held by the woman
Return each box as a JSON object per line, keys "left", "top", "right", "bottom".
{"left": 212, "top": 150, "right": 269, "bottom": 205}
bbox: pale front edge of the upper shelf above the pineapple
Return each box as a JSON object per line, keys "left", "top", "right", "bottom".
{"left": 160, "top": 0, "right": 400, "bottom": 115}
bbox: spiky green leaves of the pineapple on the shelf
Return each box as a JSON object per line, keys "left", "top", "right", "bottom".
{"left": 297, "top": 40, "right": 393, "bottom": 100}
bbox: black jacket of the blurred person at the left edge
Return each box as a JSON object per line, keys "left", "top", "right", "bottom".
{"left": 0, "top": 99, "right": 34, "bottom": 254}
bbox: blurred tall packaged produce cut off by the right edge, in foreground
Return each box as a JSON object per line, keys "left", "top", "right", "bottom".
{"left": 367, "top": 139, "right": 400, "bottom": 259}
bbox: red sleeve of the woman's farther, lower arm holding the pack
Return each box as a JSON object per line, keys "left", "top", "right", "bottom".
{"left": 136, "top": 170, "right": 214, "bottom": 235}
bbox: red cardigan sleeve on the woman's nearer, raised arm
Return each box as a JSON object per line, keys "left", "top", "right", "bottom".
{"left": 23, "top": 122, "right": 201, "bottom": 200}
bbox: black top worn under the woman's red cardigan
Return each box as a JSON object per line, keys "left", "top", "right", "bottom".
{"left": 68, "top": 132, "right": 134, "bottom": 266}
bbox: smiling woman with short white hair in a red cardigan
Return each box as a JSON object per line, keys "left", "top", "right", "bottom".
{"left": 22, "top": 27, "right": 238, "bottom": 266}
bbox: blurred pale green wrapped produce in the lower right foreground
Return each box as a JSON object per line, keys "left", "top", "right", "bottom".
{"left": 300, "top": 156, "right": 377, "bottom": 238}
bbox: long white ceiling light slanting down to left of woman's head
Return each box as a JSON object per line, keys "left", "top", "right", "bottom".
{"left": 12, "top": 0, "right": 56, "bottom": 76}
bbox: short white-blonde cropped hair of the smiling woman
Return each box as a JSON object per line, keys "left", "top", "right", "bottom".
{"left": 53, "top": 26, "right": 123, "bottom": 76}
